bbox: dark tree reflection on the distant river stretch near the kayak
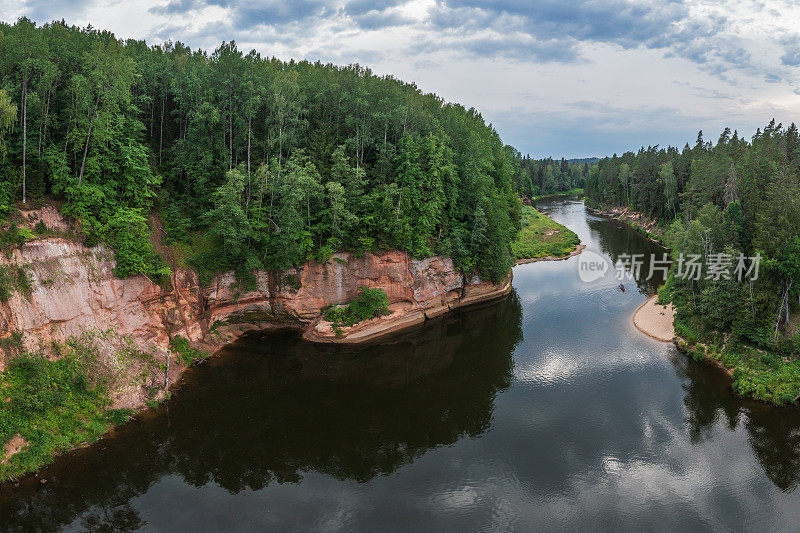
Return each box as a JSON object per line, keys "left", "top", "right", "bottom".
{"left": 586, "top": 215, "right": 666, "bottom": 294}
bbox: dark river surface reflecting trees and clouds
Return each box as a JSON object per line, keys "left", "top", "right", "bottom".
{"left": 0, "top": 201, "right": 800, "bottom": 531}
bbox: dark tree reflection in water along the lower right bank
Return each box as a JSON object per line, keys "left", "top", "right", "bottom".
{"left": 673, "top": 352, "right": 800, "bottom": 492}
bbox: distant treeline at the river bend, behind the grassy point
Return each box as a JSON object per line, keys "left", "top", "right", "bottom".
{"left": 508, "top": 152, "right": 590, "bottom": 198}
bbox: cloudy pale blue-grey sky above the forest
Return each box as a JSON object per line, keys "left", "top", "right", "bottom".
{"left": 0, "top": 0, "right": 800, "bottom": 158}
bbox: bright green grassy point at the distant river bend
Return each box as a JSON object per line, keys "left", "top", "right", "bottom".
{"left": 511, "top": 206, "right": 581, "bottom": 260}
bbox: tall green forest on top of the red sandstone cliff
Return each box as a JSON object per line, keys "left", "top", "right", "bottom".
{"left": 0, "top": 19, "right": 519, "bottom": 286}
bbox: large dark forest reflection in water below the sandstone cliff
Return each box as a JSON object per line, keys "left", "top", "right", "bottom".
{"left": 0, "top": 294, "right": 522, "bottom": 531}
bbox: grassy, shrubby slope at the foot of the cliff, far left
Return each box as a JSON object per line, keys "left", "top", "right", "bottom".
{"left": 0, "top": 330, "right": 192, "bottom": 482}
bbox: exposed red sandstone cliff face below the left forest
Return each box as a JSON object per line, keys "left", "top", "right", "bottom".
{"left": 0, "top": 207, "right": 510, "bottom": 406}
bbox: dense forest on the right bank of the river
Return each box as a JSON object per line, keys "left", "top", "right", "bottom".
{"left": 586, "top": 120, "right": 800, "bottom": 403}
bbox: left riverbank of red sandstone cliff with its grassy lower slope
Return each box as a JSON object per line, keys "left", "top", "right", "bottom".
{"left": 0, "top": 206, "right": 511, "bottom": 481}
